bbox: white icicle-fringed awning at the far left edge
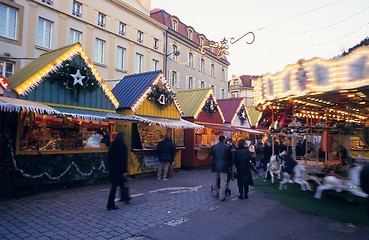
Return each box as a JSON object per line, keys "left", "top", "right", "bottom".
{"left": 0, "top": 97, "right": 60, "bottom": 114}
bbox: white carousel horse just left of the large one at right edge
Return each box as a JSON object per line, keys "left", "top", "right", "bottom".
{"left": 279, "top": 164, "right": 311, "bottom": 191}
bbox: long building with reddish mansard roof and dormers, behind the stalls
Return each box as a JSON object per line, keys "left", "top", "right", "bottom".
{"left": 150, "top": 9, "right": 230, "bottom": 99}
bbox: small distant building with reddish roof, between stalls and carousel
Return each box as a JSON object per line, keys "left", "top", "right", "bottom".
{"left": 228, "top": 75, "right": 260, "bottom": 106}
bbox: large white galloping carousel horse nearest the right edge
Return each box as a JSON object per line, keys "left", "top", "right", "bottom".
{"left": 314, "top": 164, "right": 368, "bottom": 199}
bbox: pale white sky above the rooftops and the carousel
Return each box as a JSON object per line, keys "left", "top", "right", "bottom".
{"left": 151, "top": 0, "right": 369, "bottom": 77}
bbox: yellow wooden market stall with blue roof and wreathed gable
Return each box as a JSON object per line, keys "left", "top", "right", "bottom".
{"left": 112, "top": 71, "right": 203, "bottom": 174}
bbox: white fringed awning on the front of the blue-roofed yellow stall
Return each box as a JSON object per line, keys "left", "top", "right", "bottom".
{"left": 123, "top": 114, "right": 204, "bottom": 129}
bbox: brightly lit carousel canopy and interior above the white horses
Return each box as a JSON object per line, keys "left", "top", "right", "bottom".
{"left": 254, "top": 47, "right": 369, "bottom": 165}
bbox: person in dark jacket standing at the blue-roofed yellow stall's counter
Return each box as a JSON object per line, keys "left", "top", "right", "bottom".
{"left": 156, "top": 135, "right": 177, "bottom": 180}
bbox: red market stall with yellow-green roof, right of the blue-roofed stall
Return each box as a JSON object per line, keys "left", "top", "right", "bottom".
{"left": 177, "top": 88, "right": 233, "bottom": 168}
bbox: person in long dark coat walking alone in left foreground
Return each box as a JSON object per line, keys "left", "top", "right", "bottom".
{"left": 106, "top": 132, "right": 130, "bottom": 210}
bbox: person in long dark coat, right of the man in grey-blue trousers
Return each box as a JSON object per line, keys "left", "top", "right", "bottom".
{"left": 234, "top": 139, "right": 259, "bottom": 199}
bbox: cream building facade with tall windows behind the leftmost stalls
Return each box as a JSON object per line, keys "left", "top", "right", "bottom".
{"left": 0, "top": 0, "right": 167, "bottom": 88}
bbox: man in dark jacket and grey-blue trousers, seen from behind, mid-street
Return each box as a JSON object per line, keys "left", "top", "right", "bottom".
{"left": 210, "top": 136, "right": 233, "bottom": 201}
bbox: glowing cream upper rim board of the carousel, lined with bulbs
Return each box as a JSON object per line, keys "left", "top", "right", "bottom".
{"left": 254, "top": 47, "right": 369, "bottom": 105}
